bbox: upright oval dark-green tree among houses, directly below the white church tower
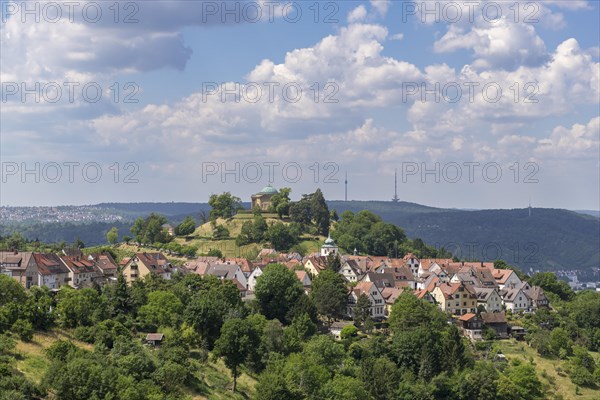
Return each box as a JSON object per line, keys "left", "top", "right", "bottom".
{"left": 310, "top": 269, "right": 348, "bottom": 324}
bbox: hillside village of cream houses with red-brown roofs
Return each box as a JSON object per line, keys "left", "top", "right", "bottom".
{"left": 0, "top": 233, "right": 549, "bottom": 340}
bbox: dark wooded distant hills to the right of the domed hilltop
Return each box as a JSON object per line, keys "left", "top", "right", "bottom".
{"left": 329, "top": 201, "right": 600, "bottom": 272}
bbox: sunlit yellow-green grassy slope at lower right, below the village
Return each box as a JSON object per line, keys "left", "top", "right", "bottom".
{"left": 494, "top": 339, "right": 600, "bottom": 400}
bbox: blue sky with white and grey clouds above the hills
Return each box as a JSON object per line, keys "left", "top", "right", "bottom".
{"left": 0, "top": 0, "right": 600, "bottom": 210}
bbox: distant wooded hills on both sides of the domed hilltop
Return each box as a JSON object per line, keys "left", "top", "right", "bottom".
{"left": 0, "top": 201, "right": 600, "bottom": 272}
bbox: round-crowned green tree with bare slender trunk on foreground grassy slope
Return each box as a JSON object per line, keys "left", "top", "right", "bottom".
{"left": 214, "top": 318, "right": 260, "bottom": 392}
